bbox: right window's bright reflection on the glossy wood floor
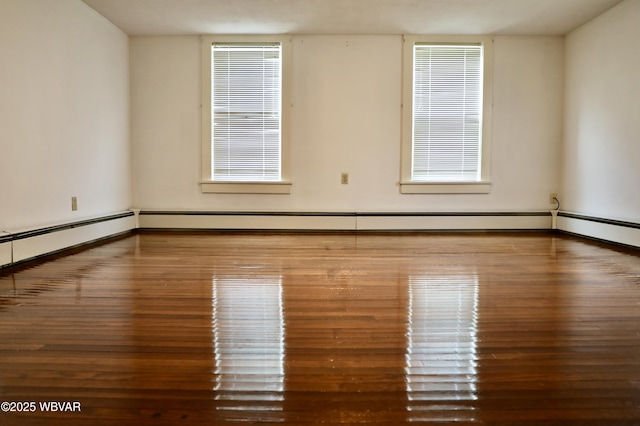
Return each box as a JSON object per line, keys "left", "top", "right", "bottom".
{"left": 405, "top": 271, "right": 478, "bottom": 421}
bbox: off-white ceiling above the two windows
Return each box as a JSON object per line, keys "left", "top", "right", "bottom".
{"left": 83, "top": 0, "right": 622, "bottom": 36}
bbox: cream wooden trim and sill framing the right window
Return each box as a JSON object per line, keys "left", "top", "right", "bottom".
{"left": 400, "top": 35, "right": 493, "bottom": 194}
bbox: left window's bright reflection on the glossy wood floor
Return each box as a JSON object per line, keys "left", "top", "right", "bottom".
{"left": 212, "top": 275, "right": 285, "bottom": 422}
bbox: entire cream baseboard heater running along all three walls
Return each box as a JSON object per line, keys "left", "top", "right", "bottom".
{"left": 0, "top": 210, "right": 640, "bottom": 268}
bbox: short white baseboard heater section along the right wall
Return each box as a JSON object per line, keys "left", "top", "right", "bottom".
{"left": 558, "top": 212, "right": 640, "bottom": 247}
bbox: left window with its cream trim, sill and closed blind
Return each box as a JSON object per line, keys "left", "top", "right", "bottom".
{"left": 201, "top": 36, "right": 291, "bottom": 193}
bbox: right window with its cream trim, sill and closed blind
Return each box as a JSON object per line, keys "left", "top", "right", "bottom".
{"left": 400, "top": 36, "right": 492, "bottom": 193}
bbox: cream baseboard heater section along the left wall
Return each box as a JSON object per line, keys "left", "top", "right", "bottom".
{"left": 0, "top": 211, "right": 136, "bottom": 267}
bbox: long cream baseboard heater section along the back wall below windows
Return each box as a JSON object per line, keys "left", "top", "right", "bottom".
{"left": 139, "top": 210, "right": 551, "bottom": 231}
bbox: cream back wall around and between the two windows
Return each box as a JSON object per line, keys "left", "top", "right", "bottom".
{"left": 130, "top": 35, "right": 564, "bottom": 212}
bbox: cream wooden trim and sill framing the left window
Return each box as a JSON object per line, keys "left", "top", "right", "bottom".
{"left": 200, "top": 35, "right": 292, "bottom": 194}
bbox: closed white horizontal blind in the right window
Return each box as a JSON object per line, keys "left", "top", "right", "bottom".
{"left": 411, "top": 43, "right": 483, "bottom": 182}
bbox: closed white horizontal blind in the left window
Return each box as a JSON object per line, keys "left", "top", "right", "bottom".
{"left": 211, "top": 43, "right": 282, "bottom": 182}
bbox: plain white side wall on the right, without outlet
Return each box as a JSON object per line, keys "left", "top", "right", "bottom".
{"left": 560, "top": 0, "right": 640, "bottom": 223}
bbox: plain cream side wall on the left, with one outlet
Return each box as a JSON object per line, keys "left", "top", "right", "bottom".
{"left": 0, "top": 0, "right": 131, "bottom": 231}
